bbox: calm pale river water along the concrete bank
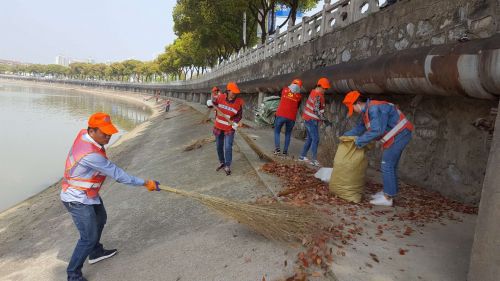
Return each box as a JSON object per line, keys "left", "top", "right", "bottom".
{"left": 0, "top": 81, "right": 152, "bottom": 212}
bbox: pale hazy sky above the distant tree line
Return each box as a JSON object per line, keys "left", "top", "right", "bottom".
{"left": 0, "top": 0, "right": 323, "bottom": 64}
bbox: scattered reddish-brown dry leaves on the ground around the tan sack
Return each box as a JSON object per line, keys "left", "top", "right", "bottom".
{"left": 258, "top": 162, "right": 477, "bottom": 280}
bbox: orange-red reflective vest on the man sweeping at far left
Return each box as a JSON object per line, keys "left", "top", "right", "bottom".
{"left": 62, "top": 129, "right": 108, "bottom": 198}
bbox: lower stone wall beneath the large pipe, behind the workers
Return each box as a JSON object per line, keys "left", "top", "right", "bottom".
{"left": 232, "top": 93, "right": 497, "bottom": 204}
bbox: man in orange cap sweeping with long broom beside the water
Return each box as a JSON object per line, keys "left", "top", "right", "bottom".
{"left": 60, "top": 112, "right": 160, "bottom": 281}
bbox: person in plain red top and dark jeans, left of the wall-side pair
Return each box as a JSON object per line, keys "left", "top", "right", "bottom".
{"left": 274, "top": 79, "right": 302, "bottom": 156}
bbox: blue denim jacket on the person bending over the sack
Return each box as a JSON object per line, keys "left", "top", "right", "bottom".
{"left": 344, "top": 99, "right": 406, "bottom": 147}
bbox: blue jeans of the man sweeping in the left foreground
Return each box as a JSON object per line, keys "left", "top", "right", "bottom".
{"left": 63, "top": 199, "right": 107, "bottom": 280}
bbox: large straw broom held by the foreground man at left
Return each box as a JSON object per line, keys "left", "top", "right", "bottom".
{"left": 159, "top": 185, "right": 327, "bottom": 242}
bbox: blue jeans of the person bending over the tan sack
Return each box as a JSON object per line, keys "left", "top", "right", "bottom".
{"left": 380, "top": 129, "right": 411, "bottom": 196}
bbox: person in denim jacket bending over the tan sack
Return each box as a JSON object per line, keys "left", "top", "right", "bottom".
{"left": 343, "top": 91, "right": 413, "bottom": 206}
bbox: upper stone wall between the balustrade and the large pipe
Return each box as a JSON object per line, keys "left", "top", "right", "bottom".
{"left": 221, "top": 0, "right": 499, "bottom": 85}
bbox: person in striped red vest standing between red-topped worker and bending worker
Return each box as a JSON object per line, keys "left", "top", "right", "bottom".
{"left": 299, "top": 77, "right": 330, "bottom": 167}
